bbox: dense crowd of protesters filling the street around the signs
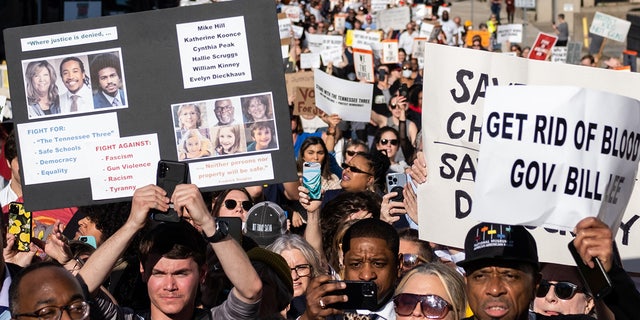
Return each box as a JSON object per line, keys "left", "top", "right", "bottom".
{"left": 0, "top": 0, "right": 640, "bottom": 320}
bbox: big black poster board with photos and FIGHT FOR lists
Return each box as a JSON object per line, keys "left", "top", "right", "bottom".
{"left": 5, "top": 0, "right": 296, "bottom": 210}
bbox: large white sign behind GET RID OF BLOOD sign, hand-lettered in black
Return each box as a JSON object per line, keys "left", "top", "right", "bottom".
{"left": 417, "top": 43, "right": 640, "bottom": 272}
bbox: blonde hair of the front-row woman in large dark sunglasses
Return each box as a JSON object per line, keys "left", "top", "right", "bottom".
{"left": 394, "top": 262, "right": 467, "bottom": 319}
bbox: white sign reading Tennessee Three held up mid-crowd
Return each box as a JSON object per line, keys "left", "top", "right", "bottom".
{"left": 313, "top": 69, "right": 373, "bottom": 122}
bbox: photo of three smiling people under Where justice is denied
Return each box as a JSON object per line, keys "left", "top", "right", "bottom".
{"left": 22, "top": 49, "right": 127, "bottom": 119}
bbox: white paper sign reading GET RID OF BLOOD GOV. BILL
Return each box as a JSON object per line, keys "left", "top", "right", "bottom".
{"left": 476, "top": 86, "right": 640, "bottom": 231}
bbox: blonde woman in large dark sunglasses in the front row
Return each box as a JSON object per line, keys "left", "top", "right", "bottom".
{"left": 393, "top": 263, "right": 467, "bottom": 320}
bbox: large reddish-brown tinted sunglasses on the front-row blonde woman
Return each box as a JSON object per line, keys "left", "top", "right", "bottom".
{"left": 393, "top": 293, "right": 453, "bottom": 319}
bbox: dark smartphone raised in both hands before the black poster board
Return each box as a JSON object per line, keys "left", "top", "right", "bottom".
{"left": 151, "top": 160, "right": 189, "bottom": 222}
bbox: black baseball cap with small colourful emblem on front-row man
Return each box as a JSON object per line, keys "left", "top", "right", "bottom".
{"left": 458, "top": 222, "right": 540, "bottom": 271}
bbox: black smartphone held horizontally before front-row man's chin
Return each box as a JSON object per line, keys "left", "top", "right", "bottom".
{"left": 328, "top": 280, "right": 378, "bottom": 310}
